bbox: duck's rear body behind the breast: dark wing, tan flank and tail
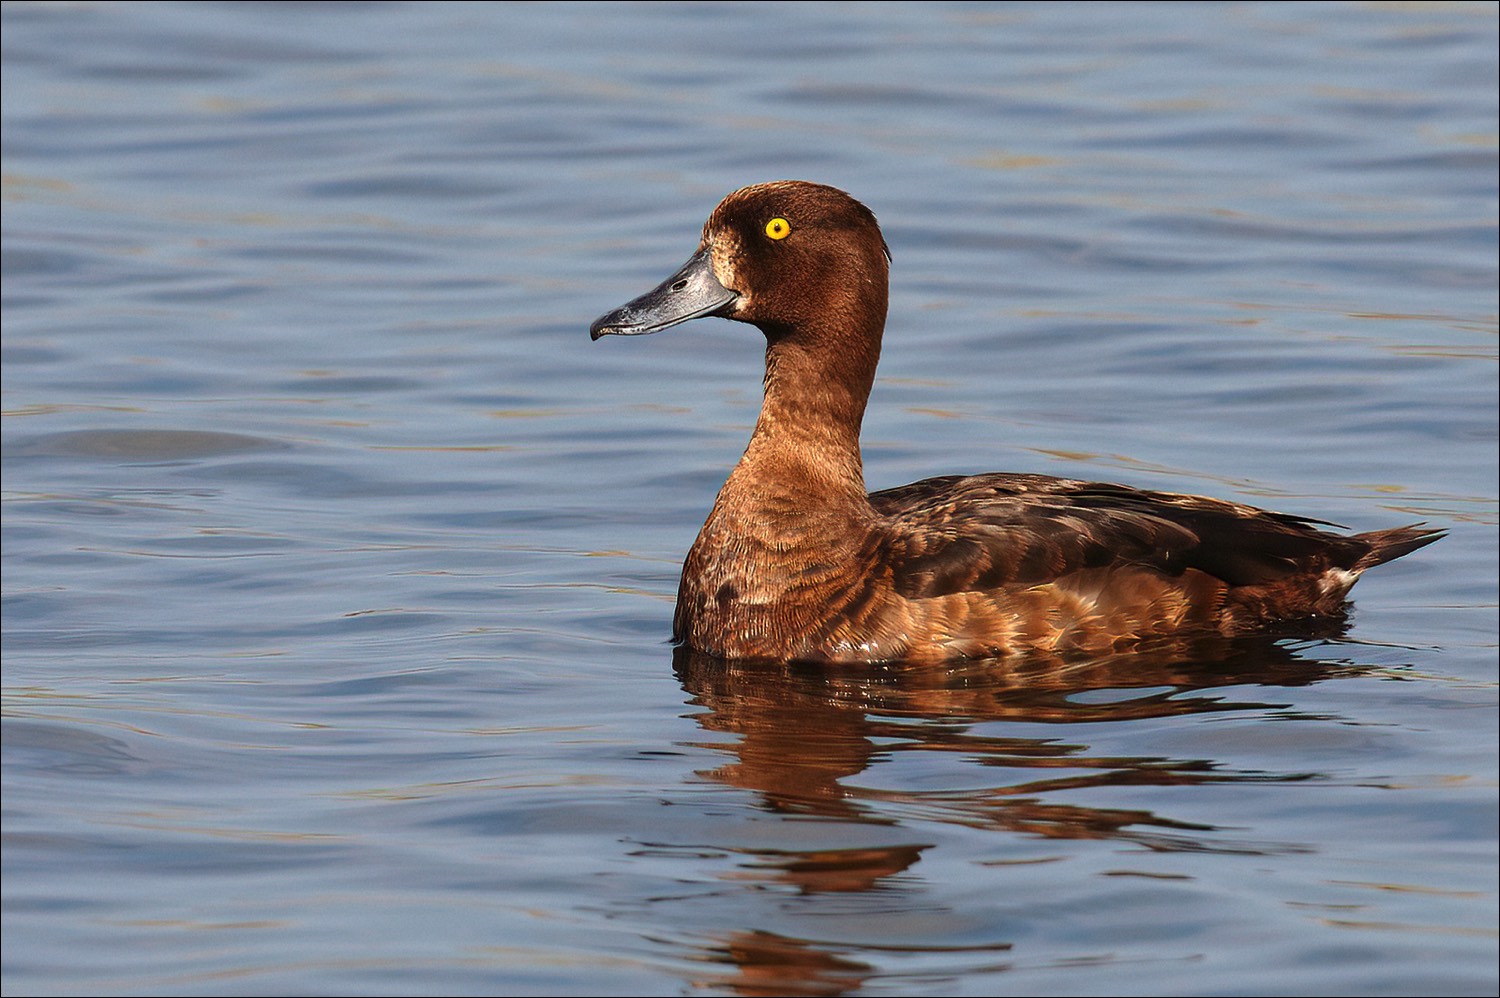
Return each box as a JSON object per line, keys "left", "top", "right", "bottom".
{"left": 869, "top": 474, "right": 1440, "bottom": 653}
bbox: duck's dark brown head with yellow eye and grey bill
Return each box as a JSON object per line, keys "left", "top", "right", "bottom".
{"left": 590, "top": 180, "right": 890, "bottom": 339}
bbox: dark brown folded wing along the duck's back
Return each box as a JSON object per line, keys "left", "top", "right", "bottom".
{"left": 870, "top": 474, "right": 1371, "bottom": 597}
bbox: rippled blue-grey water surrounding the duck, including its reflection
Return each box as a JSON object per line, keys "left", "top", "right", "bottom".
{"left": 3, "top": 3, "right": 1497, "bottom": 995}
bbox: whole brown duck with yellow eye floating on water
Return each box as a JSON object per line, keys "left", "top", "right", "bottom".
{"left": 590, "top": 180, "right": 1445, "bottom": 665}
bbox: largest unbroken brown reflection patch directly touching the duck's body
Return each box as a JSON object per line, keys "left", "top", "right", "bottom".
{"left": 675, "top": 638, "right": 1358, "bottom": 849}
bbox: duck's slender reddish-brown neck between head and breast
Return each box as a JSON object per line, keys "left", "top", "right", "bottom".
{"left": 725, "top": 313, "right": 885, "bottom": 512}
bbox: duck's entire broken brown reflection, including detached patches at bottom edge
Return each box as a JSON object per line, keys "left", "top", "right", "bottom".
{"left": 675, "top": 638, "right": 1364, "bottom": 995}
